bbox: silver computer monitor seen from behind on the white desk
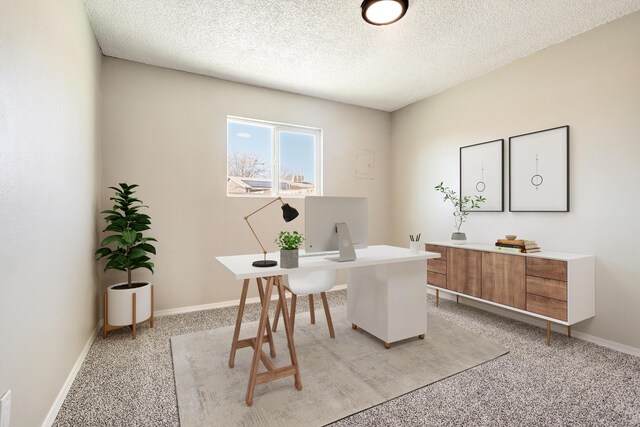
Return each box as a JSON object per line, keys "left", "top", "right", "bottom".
{"left": 304, "top": 196, "right": 369, "bottom": 261}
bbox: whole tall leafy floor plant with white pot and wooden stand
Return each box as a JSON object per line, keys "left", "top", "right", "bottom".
{"left": 96, "top": 183, "right": 156, "bottom": 338}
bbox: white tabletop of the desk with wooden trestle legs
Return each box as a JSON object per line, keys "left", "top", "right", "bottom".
{"left": 216, "top": 245, "right": 440, "bottom": 279}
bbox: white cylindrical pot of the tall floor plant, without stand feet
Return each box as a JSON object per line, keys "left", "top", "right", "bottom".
{"left": 107, "top": 282, "right": 152, "bottom": 326}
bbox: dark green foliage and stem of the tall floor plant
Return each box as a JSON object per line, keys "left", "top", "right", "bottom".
{"left": 96, "top": 183, "right": 157, "bottom": 287}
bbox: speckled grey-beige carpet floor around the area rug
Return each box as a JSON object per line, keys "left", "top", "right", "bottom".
{"left": 54, "top": 291, "right": 640, "bottom": 427}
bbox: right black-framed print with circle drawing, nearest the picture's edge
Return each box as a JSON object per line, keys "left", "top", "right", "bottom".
{"left": 509, "top": 126, "right": 569, "bottom": 212}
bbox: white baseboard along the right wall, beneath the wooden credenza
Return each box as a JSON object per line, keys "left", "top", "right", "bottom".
{"left": 428, "top": 289, "right": 640, "bottom": 357}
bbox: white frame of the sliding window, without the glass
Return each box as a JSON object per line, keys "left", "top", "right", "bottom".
{"left": 225, "top": 116, "right": 323, "bottom": 199}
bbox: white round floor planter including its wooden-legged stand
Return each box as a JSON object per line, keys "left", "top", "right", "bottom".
{"left": 104, "top": 282, "right": 153, "bottom": 338}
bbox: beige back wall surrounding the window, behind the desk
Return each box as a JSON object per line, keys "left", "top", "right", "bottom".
{"left": 102, "top": 57, "right": 391, "bottom": 310}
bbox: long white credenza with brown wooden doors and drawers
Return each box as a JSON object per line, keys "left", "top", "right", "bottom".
{"left": 425, "top": 242, "right": 595, "bottom": 343}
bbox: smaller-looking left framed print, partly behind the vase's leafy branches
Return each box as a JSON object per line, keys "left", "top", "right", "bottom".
{"left": 460, "top": 139, "right": 504, "bottom": 212}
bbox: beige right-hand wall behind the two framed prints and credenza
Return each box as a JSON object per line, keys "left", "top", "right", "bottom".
{"left": 391, "top": 12, "right": 640, "bottom": 348}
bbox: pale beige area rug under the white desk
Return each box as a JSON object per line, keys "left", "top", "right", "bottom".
{"left": 171, "top": 307, "right": 507, "bottom": 427}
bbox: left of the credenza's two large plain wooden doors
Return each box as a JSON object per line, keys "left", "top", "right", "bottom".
{"left": 447, "top": 248, "right": 482, "bottom": 298}
